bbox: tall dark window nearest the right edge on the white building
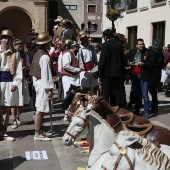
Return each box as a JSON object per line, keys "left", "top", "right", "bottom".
{"left": 152, "top": 21, "right": 165, "bottom": 47}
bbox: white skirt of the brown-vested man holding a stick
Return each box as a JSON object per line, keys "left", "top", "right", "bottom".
{"left": 34, "top": 79, "right": 50, "bottom": 113}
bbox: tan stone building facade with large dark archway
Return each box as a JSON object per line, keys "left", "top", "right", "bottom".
{"left": 0, "top": 0, "right": 48, "bottom": 41}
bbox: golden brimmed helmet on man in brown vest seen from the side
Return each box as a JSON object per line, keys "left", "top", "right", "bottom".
{"left": 35, "top": 32, "right": 52, "bottom": 45}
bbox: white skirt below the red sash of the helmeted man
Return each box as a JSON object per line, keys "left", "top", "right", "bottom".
{"left": 80, "top": 71, "right": 98, "bottom": 87}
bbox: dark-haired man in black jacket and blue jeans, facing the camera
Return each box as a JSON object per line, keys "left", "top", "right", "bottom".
{"left": 128, "top": 38, "right": 154, "bottom": 119}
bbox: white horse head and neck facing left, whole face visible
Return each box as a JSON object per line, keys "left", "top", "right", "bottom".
{"left": 62, "top": 109, "right": 116, "bottom": 170}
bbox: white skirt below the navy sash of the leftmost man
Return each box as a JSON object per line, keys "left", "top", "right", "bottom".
{"left": 0, "top": 82, "right": 19, "bottom": 106}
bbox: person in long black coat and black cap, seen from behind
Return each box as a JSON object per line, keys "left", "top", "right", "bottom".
{"left": 98, "top": 29, "right": 126, "bottom": 107}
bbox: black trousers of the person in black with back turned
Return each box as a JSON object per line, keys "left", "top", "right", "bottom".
{"left": 102, "top": 77, "right": 126, "bottom": 108}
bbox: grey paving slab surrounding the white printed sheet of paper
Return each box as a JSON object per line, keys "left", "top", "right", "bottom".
{"left": 13, "top": 139, "right": 61, "bottom": 170}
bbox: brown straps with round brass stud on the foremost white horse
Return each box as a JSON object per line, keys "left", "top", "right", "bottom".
{"left": 101, "top": 142, "right": 134, "bottom": 170}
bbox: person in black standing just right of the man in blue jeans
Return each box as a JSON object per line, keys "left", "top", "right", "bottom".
{"left": 149, "top": 40, "right": 164, "bottom": 115}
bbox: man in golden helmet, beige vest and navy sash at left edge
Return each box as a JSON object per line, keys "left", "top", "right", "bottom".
{"left": 0, "top": 29, "right": 23, "bottom": 141}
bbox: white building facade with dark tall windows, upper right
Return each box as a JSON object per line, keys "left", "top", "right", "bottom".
{"left": 103, "top": 0, "right": 170, "bottom": 48}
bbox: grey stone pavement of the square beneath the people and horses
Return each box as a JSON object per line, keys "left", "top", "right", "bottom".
{"left": 0, "top": 85, "right": 170, "bottom": 170}
